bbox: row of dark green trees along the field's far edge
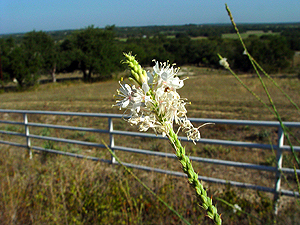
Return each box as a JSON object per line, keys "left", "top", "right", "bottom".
{"left": 0, "top": 26, "right": 300, "bottom": 87}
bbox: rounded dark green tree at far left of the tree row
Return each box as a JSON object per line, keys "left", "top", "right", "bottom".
{"left": 3, "top": 31, "right": 57, "bottom": 87}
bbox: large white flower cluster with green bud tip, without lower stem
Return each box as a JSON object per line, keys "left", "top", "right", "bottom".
{"left": 116, "top": 54, "right": 200, "bottom": 143}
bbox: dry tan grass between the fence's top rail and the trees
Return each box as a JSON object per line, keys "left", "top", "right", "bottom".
{"left": 0, "top": 67, "right": 300, "bottom": 121}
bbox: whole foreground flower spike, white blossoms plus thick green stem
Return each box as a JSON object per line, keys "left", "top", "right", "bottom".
{"left": 115, "top": 53, "right": 222, "bottom": 224}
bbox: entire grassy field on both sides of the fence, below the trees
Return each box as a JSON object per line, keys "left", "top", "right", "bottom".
{"left": 0, "top": 67, "right": 300, "bottom": 224}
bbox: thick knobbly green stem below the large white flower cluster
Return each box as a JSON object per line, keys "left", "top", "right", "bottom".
{"left": 168, "top": 129, "right": 222, "bottom": 224}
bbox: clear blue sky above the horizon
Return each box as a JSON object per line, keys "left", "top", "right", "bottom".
{"left": 0, "top": 0, "right": 300, "bottom": 34}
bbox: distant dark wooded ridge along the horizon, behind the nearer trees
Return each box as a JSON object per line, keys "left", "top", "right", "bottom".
{"left": 0, "top": 22, "right": 300, "bottom": 41}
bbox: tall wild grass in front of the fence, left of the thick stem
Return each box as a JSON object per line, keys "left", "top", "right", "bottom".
{"left": 0, "top": 148, "right": 225, "bottom": 225}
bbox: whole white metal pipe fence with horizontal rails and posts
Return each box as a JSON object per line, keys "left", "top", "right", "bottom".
{"left": 0, "top": 109, "right": 300, "bottom": 206}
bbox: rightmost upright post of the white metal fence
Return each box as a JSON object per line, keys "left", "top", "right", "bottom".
{"left": 274, "top": 126, "right": 284, "bottom": 215}
